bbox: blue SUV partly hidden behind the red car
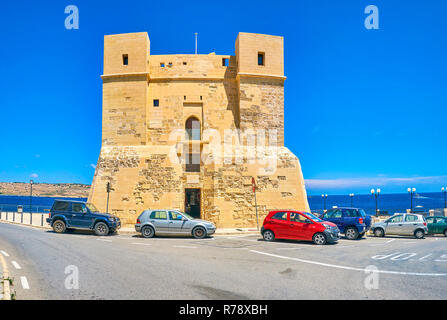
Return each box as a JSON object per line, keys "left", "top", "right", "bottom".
{"left": 320, "top": 208, "right": 371, "bottom": 240}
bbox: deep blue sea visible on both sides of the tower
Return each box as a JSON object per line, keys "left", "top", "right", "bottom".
{"left": 0, "top": 192, "right": 444, "bottom": 215}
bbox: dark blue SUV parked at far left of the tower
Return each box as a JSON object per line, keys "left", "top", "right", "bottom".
{"left": 47, "top": 200, "right": 121, "bottom": 236}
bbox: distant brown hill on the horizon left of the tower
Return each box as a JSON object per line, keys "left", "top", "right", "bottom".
{"left": 0, "top": 182, "right": 90, "bottom": 198}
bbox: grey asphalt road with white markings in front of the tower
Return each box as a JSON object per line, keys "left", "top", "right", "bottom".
{"left": 0, "top": 223, "right": 447, "bottom": 300}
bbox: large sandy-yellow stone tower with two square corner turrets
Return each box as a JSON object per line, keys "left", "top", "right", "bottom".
{"left": 89, "top": 33, "right": 309, "bottom": 228}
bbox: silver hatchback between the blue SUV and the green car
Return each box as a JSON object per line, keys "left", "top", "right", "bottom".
{"left": 371, "top": 213, "right": 428, "bottom": 239}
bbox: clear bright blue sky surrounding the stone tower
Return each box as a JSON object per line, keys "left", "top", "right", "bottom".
{"left": 0, "top": 0, "right": 447, "bottom": 194}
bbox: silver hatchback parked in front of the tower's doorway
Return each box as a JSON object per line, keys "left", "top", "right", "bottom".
{"left": 135, "top": 210, "right": 216, "bottom": 239}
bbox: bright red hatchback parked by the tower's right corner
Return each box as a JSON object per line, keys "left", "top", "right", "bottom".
{"left": 261, "top": 210, "right": 340, "bottom": 245}
